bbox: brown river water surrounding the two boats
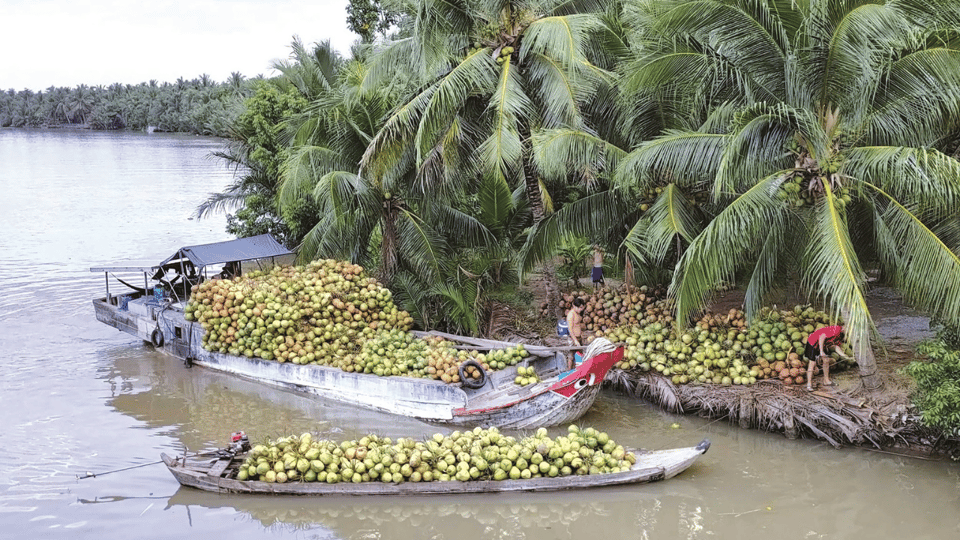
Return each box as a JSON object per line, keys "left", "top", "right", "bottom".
{"left": 0, "top": 129, "right": 960, "bottom": 540}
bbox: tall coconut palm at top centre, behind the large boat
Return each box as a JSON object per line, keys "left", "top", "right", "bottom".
{"left": 361, "top": 0, "right": 624, "bottom": 318}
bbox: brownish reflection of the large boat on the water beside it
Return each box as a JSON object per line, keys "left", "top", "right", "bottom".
{"left": 101, "top": 345, "right": 437, "bottom": 450}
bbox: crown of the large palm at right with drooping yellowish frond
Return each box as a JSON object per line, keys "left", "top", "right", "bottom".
{"left": 617, "top": 0, "right": 960, "bottom": 391}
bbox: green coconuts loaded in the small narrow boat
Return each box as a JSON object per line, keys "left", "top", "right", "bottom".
{"left": 236, "top": 425, "right": 637, "bottom": 484}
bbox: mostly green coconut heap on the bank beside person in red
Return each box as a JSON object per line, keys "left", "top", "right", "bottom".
{"left": 607, "top": 301, "right": 848, "bottom": 385}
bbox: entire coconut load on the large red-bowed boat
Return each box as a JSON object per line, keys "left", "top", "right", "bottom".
{"left": 184, "top": 260, "right": 527, "bottom": 383}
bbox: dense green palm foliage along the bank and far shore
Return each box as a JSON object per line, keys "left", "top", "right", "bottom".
{"left": 18, "top": 0, "right": 960, "bottom": 388}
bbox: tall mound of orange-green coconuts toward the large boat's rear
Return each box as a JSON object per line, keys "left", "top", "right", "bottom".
{"left": 184, "top": 260, "right": 413, "bottom": 364}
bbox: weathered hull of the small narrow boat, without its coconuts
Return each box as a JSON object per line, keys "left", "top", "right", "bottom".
{"left": 160, "top": 439, "right": 710, "bottom": 496}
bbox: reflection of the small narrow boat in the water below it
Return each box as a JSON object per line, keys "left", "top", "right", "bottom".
{"left": 161, "top": 488, "right": 702, "bottom": 539}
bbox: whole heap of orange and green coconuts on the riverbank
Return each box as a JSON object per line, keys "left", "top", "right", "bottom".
{"left": 548, "top": 287, "right": 851, "bottom": 385}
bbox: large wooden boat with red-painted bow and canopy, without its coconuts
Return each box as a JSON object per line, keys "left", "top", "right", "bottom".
{"left": 91, "top": 235, "right": 623, "bottom": 428}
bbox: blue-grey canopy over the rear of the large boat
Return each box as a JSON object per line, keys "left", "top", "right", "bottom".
{"left": 90, "top": 234, "right": 292, "bottom": 273}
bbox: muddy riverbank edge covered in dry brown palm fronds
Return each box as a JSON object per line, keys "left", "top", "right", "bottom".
{"left": 510, "top": 277, "right": 960, "bottom": 458}
